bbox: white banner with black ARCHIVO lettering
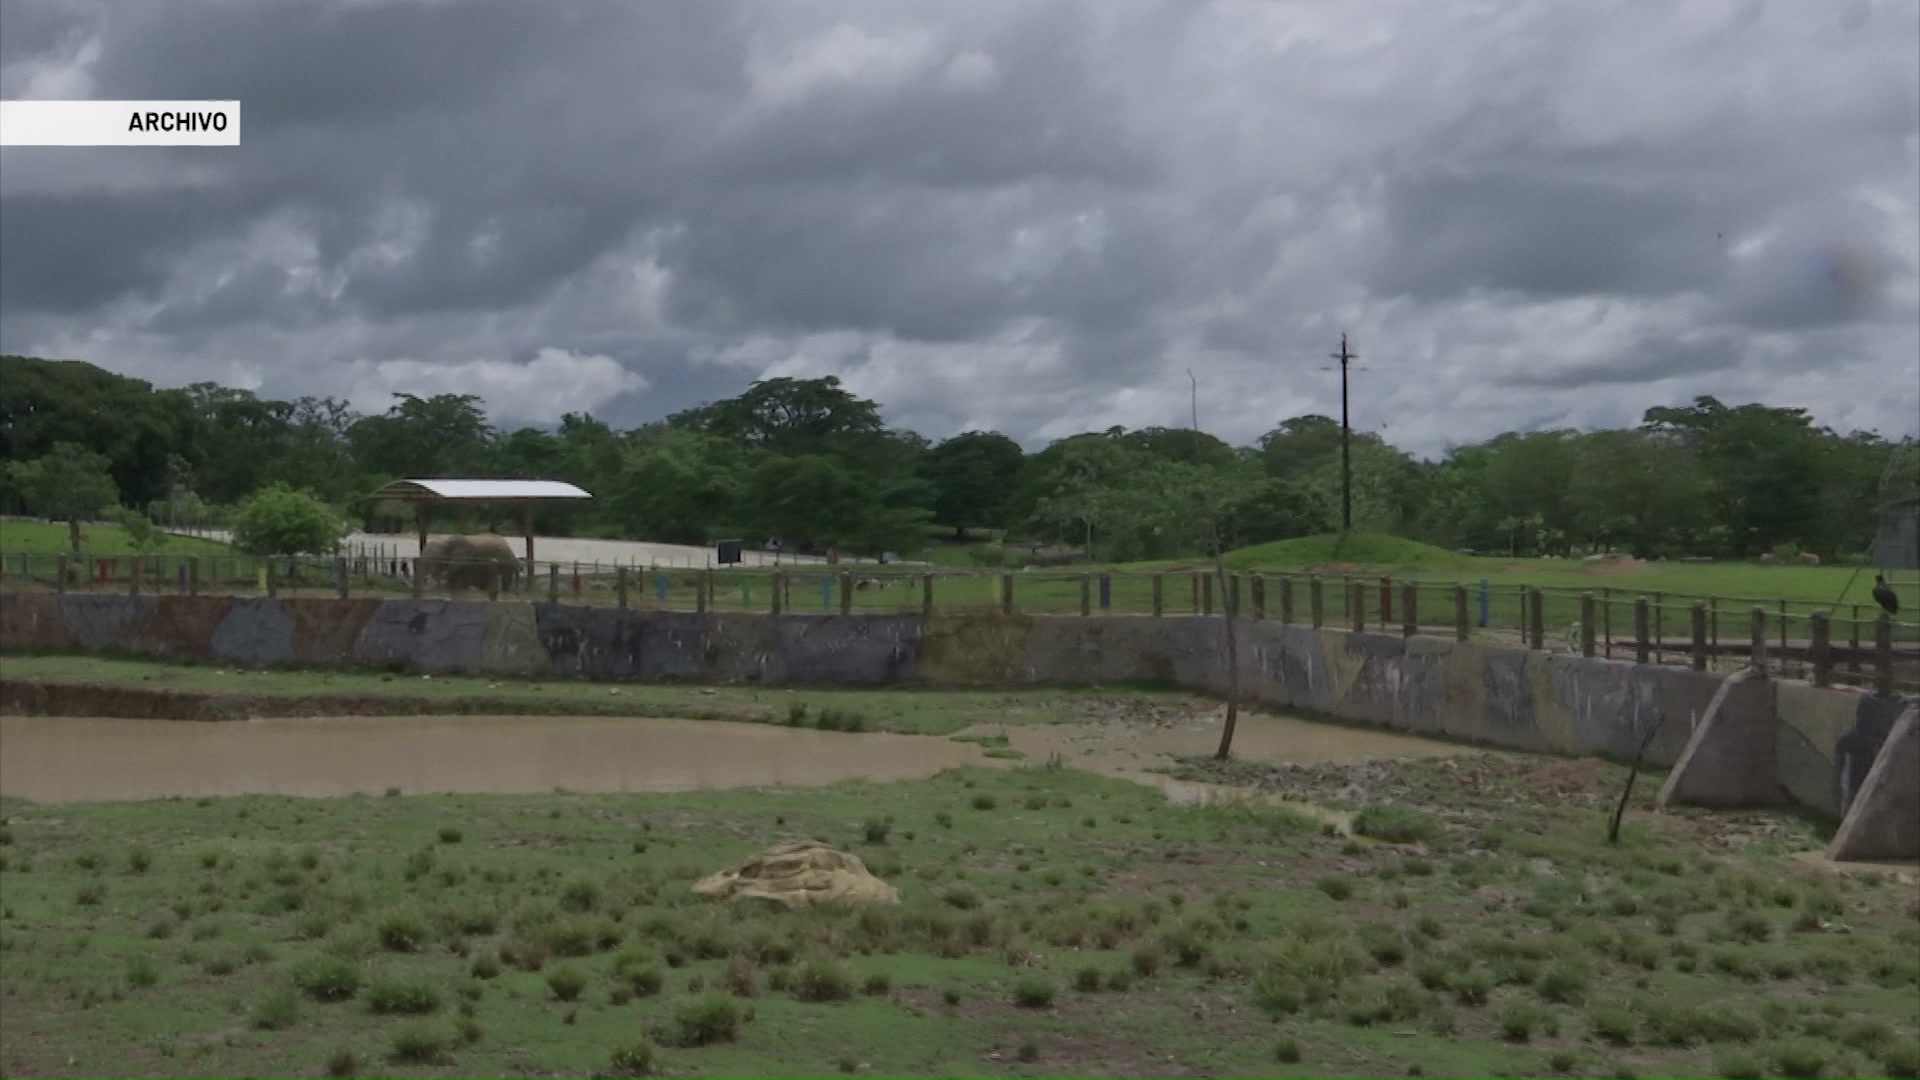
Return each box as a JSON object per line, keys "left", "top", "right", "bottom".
{"left": 0, "top": 102, "right": 240, "bottom": 146}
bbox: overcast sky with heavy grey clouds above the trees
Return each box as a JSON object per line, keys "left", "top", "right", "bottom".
{"left": 0, "top": 0, "right": 1920, "bottom": 454}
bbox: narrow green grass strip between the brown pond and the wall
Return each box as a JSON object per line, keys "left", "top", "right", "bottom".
{"left": 6, "top": 655, "right": 1196, "bottom": 734}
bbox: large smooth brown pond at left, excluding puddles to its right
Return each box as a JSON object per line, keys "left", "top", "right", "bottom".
{"left": 0, "top": 717, "right": 979, "bottom": 803}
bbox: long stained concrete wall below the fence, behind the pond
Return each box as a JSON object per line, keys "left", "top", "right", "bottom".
{"left": 0, "top": 594, "right": 1908, "bottom": 834}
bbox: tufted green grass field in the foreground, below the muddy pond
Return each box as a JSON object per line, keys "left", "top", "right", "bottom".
{"left": 0, "top": 737, "right": 1920, "bottom": 1080}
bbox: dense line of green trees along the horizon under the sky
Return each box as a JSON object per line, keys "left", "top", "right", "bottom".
{"left": 0, "top": 356, "right": 1920, "bottom": 561}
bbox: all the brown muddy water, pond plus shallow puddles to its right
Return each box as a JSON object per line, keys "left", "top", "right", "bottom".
{"left": 0, "top": 709, "right": 1461, "bottom": 803}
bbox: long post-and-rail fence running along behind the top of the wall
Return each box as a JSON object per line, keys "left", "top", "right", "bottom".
{"left": 0, "top": 553, "right": 1920, "bottom": 692}
